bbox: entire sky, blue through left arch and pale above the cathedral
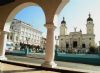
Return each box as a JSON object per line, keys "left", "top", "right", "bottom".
{"left": 15, "top": 0, "right": 100, "bottom": 44}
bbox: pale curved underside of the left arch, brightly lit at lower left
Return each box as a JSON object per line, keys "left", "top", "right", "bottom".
{"left": 3, "top": 2, "right": 45, "bottom": 32}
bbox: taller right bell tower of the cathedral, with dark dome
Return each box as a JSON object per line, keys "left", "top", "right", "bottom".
{"left": 86, "top": 14, "right": 94, "bottom": 34}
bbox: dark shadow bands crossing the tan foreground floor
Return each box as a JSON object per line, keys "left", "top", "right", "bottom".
{"left": 0, "top": 60, "right": 85, "bottom": 73}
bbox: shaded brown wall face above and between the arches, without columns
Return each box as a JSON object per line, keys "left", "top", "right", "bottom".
{"left": 0, "top": 0, "right": 69, "bottom": 30}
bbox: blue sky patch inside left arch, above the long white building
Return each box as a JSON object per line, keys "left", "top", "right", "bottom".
{"left": 15, "top": 6, "right": 45, "bottom": 32}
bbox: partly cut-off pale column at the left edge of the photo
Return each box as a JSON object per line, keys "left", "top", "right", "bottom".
{"left": 0, "top": 31, "right": 7, "bottom": 60}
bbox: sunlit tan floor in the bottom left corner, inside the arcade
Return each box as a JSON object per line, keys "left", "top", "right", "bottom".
{"left": 0, "top": 63, "right": 59, "bottom": 73}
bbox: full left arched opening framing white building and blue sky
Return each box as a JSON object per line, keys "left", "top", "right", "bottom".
{"left": 4, "top": 2, "right": 46, "bottom": 62}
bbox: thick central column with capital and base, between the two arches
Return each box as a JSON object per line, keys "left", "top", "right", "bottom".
{"left": 42, "top": 24, "right": 57, "bottom": 68}
